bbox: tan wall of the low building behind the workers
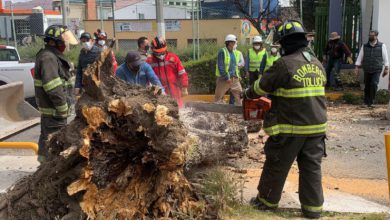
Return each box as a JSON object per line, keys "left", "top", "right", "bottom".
{"left": 84, "top": 19, "right": 258, "bottom": 49}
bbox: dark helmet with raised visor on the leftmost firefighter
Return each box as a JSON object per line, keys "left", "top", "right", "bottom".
{"left": 44, "top": 25, "right": 79, "bottom": 45}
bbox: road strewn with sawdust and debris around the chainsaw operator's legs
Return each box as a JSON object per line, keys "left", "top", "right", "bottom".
{"left": 229, "top": 104, "right": 390, "bottom": 205}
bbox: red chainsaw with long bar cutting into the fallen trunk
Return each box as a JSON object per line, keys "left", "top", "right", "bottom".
{"left": 185, "top": 97, "right": 271, "bottom": 121}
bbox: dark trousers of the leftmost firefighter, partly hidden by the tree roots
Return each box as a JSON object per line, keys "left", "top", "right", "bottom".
{"left": 38, "top": 116, "right": 67, "bottom": 162}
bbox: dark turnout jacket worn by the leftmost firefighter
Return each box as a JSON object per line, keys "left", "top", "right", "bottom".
{"left": 34, "top": 46, "right": 74, "bottom": 118}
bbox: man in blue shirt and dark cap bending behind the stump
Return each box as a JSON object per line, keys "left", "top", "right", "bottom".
{"left": 116, "top": 51, "right": 164, "bottom": 92}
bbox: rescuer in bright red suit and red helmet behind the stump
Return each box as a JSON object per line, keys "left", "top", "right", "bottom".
{"left": 146, "top": 37, "right": 188, "bottom": 108}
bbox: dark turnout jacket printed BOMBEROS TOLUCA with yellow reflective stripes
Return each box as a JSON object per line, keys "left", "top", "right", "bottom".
{"left": 251, "top": 48, "right": 327, "bottom": 137}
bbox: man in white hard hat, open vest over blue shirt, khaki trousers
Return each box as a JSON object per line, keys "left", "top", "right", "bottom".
{"left": 214, "top": 34, "right": 242, "bottom": 105}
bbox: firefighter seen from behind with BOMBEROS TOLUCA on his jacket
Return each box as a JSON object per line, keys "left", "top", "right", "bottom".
{"left": 244, "top": 21, "right": 327, "bottom": 218}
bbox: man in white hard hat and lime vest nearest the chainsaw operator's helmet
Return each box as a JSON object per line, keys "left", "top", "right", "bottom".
{"left": 245, "top": 36, "right": 267, "bottom": 85}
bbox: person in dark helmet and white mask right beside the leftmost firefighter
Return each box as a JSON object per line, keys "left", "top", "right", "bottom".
{"left": 75, "top": 32, "right": 102, "bottom": 95}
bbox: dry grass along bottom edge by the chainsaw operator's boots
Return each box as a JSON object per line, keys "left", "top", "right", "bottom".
{"left": 200, "top": 168, "right": 390, "bottom": 220}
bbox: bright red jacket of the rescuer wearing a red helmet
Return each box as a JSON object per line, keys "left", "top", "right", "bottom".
{"left": 146, "top": 52, "right": 188, "bottom": 107}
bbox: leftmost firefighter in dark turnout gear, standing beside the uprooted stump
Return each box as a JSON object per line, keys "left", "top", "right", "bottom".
{"left": 34, "top": 25, "right": 78, "bottom": 162}
